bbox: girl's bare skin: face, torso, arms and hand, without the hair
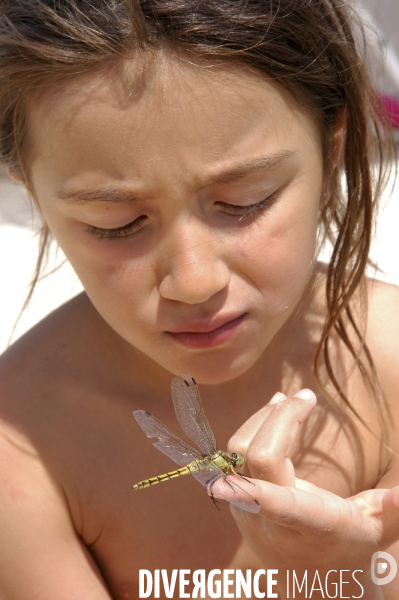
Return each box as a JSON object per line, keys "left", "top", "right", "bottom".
{"left": 0, "top": 55, "right": 399, "bottom": 600}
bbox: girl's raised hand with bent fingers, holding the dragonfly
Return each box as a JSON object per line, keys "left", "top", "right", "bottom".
{"left": 212, "top": 390, "right": 399, "bottom": 598}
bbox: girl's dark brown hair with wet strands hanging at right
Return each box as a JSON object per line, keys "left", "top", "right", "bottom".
{"left": 0, "top": 0, "right": 393, "bottom": 422}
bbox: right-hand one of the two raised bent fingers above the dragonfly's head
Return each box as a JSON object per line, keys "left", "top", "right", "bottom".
{"left": 245, "top": 390, "right": 316, "bottom": 486}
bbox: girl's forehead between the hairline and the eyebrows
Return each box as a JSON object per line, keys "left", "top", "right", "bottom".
{"left": 29, "top": 55, "right": 320, "bottom": 190}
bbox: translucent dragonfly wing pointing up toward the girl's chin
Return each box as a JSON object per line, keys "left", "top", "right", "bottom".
{"left": 172, "top": 373, "right": 216, "bottom": 454}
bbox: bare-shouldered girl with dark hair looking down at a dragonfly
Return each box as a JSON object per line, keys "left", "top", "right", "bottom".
{"left": 0, "top": 0, "right": 399, "bottom": 600}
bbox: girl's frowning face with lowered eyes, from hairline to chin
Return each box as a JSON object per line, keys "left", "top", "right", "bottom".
{"left": 29, "top": 58, "right": 323, "bottom": 383}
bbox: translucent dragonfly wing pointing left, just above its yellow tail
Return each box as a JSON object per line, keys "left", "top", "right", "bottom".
{"left": 133, "top": 410, "right": 201, "bottom": 466}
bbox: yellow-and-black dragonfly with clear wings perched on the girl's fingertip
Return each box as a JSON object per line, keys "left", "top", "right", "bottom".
{"left": 133, "top": 373, "right": 260, "bottom": 513}
